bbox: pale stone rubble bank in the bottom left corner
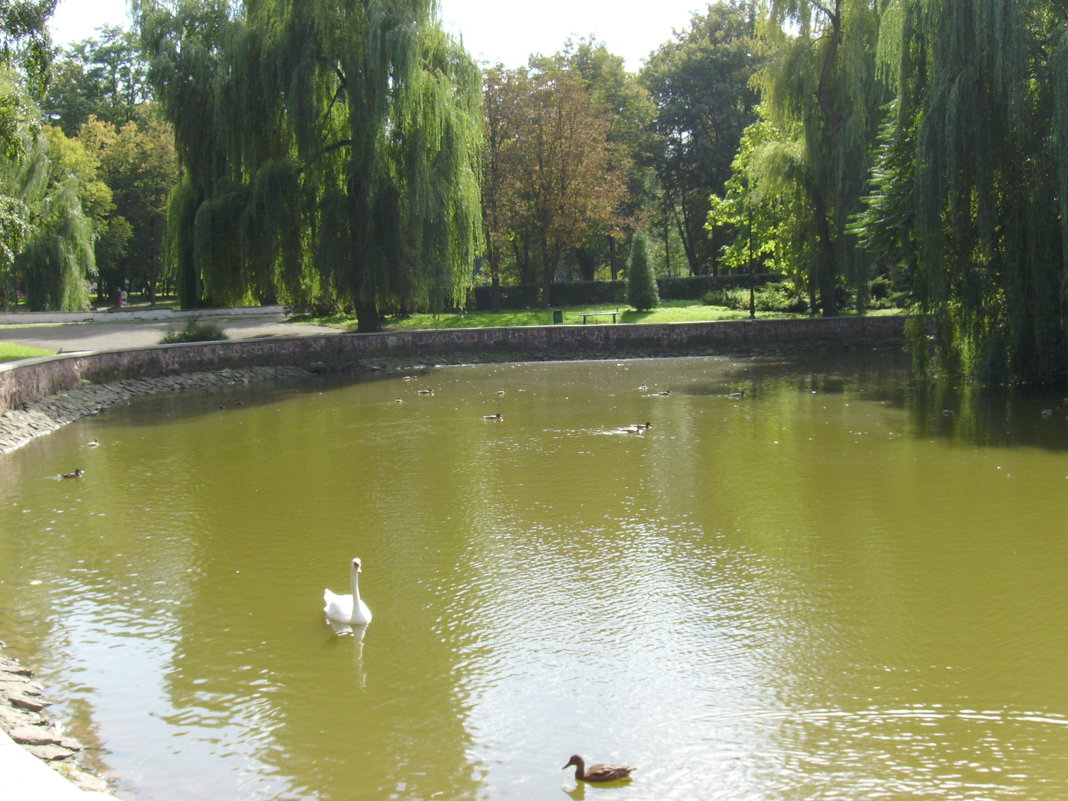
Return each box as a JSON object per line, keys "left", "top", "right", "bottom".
{"left": 0, "top": 656, "right": 108, "bottom": 792}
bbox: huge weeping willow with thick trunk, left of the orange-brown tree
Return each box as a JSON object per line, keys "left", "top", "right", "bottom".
{"left": 136, "top": 0, "right": 482, "bottom": 331}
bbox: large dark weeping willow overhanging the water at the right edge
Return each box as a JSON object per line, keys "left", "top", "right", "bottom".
{"left": 860, "top": 0, "right": 1068, "bottom": 382}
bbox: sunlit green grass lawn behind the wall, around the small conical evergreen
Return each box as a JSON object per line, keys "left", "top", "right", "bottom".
{"left": 297, "top": 300, "right": 803, "bottom": 331}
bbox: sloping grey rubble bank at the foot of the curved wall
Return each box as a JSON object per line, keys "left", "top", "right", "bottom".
{"left": 0, "top": 366, "right": 310, "bottom": 454}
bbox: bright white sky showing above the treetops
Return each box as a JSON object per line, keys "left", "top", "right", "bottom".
{"left": 49, "top": 0, "right": 707, "bottom": 72}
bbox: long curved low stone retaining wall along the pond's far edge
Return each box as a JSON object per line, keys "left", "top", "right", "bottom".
{"left": 0, "top": 316, "right": 906, "bottom": 410}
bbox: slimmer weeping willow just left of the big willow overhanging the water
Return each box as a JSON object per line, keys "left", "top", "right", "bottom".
{"left": 752, "top": 0, "right": 886, "bottom": 316}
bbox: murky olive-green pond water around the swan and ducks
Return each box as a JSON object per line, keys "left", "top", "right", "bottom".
{"left": 0, "top": 354, "right": 1068, "bottom": 801}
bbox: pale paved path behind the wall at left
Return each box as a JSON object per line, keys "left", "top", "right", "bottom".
{"left": 0, "top": 307, "right": 339, "bottom": 354}
